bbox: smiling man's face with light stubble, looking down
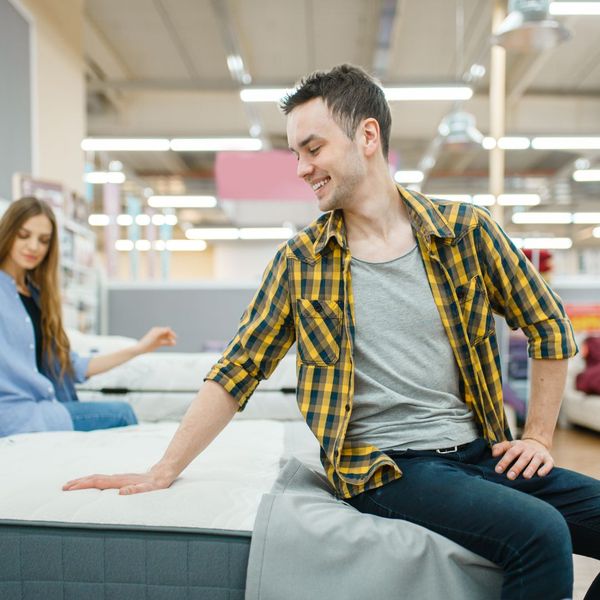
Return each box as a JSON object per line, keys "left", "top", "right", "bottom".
{"left": 287, "top": 98, "right": 366, "bottom": 212}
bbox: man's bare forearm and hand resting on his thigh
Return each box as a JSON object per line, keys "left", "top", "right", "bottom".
{"left": 492, "top": 359, "right": 568, "bottom": 479}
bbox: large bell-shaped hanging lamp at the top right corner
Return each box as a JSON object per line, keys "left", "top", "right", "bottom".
{"left": 492, "top": 0, "right": 571, "bottom": 52}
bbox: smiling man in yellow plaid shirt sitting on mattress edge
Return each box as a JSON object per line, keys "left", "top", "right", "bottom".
{"left": 65, "top": 65, "right": 600, "bottom": 600}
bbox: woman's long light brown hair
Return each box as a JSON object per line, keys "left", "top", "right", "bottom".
{"left": 0, "top": 196, "right": 73, "bottom": 377}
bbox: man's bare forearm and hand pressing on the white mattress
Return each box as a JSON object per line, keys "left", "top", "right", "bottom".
{"left": 63, "top": 381, "right": 238, "bottom": 494}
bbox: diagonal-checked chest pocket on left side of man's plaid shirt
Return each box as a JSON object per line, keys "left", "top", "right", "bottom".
{"left": 297, "top": 298, "right": 342, "bottom": 366}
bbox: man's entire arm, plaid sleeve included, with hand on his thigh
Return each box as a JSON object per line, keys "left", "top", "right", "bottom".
{"left": 474, "top": 207, "right": 577, "bottom": 479}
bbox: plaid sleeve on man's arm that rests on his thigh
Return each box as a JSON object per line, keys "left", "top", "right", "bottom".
{"left": 475, "top": 207, "right": 577, "bottom": 359}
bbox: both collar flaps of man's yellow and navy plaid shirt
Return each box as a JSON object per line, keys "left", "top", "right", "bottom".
{"left": 314, "top": 185, "right": 455, "bottom": 256}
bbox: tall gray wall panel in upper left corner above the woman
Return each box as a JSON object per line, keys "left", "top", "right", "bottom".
{"left": 0, "top": 0, "right": 32, "bottom": 200}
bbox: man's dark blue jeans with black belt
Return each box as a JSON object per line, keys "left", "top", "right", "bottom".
{"left": 348, "top": 439, "right": 600, "bottom": 600}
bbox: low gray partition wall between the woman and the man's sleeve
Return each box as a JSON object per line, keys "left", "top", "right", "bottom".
{"left": 107, "top": 282, "right": 259, "bottom": 352}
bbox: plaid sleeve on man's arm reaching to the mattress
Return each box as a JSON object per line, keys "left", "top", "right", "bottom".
{"left": 205, "top": 245, "right": 295, "bottom": 411}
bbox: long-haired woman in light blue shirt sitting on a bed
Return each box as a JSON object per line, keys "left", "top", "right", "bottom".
{"left": 0, "top": 197, "right": 175, "bottom": 436}
